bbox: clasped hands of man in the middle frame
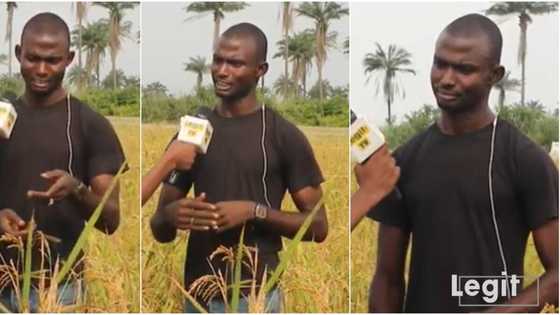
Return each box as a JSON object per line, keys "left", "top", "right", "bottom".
{"left": 163, "top": 193, "right": 255, "bottom": 233}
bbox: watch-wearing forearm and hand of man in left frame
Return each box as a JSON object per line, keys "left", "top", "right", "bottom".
{"left": 27, "top": 170, "right": 120, "bottom": 234}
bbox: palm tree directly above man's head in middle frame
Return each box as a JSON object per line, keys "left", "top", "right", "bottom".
{"left": 185, "top": 2, "right": 249, "bottom": 49}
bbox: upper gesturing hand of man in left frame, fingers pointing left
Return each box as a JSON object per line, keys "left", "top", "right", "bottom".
{"left": 27, "top": 170, "right": 80, "bottom": 200}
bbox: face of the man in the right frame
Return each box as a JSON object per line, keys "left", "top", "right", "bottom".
{"left": 431, "top": 32, "right": 497, "bottom": 112}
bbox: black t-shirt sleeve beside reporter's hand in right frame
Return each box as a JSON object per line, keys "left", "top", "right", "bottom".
{"left": 367, "top": 150, "right": 411, "bottom": 232}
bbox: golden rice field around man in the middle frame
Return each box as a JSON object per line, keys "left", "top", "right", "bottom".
{"left": 142, "top": 124, "right": 349, "bottom": 313}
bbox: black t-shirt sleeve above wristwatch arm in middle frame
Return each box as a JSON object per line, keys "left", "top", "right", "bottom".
{"left": 281, "top": 123, "right": 324, "bottom": 193}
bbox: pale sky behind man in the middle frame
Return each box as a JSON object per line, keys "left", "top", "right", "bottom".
{"left": 142, "top": 2, "right": 349, "bottom": 95}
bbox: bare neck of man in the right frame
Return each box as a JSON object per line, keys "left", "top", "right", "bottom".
{"left": 437, "top": 106, "right": 495, "bottom": 135}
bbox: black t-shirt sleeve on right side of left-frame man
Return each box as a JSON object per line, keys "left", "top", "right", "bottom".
{"left": 86, "top": 113, "right": 128, "bottom": 179}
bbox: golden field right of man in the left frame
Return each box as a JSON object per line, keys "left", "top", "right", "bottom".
{"left": 85, "top": 117, "right": 140, "bottom": 313}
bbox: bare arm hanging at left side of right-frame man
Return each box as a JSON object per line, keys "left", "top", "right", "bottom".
{"left": 369, "top": 224, "right": 410, "bottom": 313}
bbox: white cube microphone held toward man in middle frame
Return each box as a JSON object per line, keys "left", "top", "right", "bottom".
{"left": 177, "top": 114, "right": 214, "bottom": 154}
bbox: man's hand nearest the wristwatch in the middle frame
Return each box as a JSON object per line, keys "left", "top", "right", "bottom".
{"left": 216, "top": 200, "right": 255, "bottom": 233}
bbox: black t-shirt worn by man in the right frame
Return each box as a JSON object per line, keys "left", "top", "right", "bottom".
{"left": 369, "top": 120, "right": 558, "bottom": 312}
